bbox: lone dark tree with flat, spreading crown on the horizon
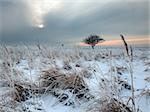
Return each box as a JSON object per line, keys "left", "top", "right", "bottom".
{"left": 83, "top": 35, "right": 104, "bottom": 49}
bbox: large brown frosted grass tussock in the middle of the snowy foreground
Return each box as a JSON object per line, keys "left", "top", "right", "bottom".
{"left": 40, "top": 69, "right": 91, "bottom": 104}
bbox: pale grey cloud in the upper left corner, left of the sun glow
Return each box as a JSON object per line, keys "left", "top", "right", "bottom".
{"left": 0, "top": 0, "right": 31, "bottom": 33}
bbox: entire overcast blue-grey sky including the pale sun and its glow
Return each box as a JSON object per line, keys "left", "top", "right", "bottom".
{"left": 0, "top": 0, "right": 149, "bottom": 44}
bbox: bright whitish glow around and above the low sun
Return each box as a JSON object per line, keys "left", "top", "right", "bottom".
{"left": 30, "top": 0, "right": 61, "bottom": 28}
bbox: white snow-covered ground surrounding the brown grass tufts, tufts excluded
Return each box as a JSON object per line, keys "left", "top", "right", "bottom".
{"left": 0, "top": 46, "right": 150, "bottom": 112}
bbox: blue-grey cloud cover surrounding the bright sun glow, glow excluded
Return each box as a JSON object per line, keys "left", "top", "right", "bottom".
{"left": 0, "top": 0, "right": 149, "bottom": 43}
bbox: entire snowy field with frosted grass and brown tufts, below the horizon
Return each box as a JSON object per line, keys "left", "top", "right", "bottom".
{"left": 0, "top": 45, "right": 150, "bottom": 112}
